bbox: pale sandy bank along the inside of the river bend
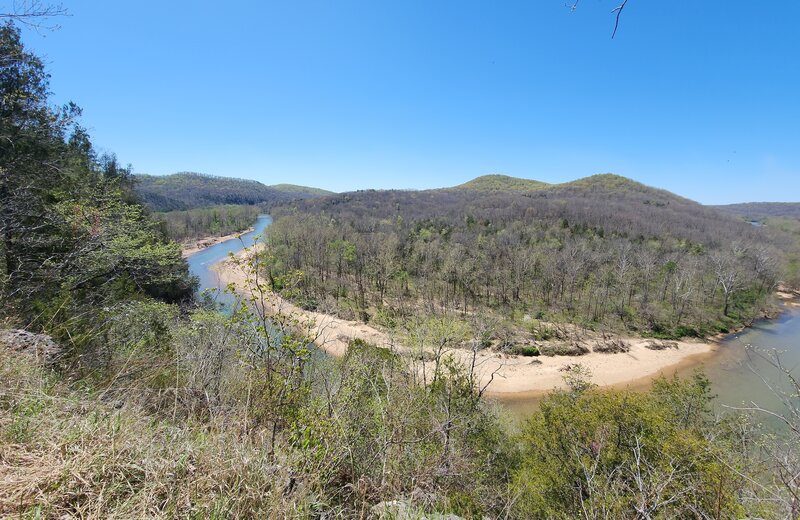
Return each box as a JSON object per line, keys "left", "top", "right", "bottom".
{"left": 214, "top": 246, "right": 717, "bottom": 398}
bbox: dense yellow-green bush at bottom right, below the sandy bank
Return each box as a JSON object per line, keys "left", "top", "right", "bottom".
{"left": 514, "top": 376, "right": 758, "bottom": 518}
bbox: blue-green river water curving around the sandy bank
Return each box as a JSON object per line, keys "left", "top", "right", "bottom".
{"left": 187, "top": 215, "right": 800, "bottom": 415}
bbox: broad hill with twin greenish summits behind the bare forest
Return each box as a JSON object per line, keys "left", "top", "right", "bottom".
{"left": 282, "top": 174, "right": 754, "bottom": 250}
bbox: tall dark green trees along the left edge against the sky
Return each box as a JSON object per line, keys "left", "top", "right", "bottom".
{"left": 0, "top": 20, "right": 193, "bottom": 355}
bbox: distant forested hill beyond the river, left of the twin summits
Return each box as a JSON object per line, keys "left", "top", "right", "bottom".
{"left": 135, "top": 172, "right": 331, "bottom": 211}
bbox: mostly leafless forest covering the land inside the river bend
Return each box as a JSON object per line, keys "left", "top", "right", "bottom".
{"left": 268, "top": 175, "right": 791, "bottom": 336}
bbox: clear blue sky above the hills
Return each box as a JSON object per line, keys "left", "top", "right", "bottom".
{"left": 15, "top": 0, "right": 800, "bottom": 203}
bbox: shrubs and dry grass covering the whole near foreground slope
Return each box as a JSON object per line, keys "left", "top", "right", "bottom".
{"left": 0, "top": 302, "right": 788, "bottom": 519}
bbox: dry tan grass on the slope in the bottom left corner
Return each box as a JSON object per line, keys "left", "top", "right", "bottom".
{"left": 0, "top": 350, "right": 322, "bottom": 518}
